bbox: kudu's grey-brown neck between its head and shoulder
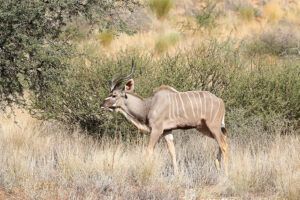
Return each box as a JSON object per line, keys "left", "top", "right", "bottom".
{"left": 124, "top": 93, "right": 151, "bottom": 124}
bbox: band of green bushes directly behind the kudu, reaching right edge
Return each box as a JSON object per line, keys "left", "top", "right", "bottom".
{"left": 30, "top": 41, "right": 300, "bottom": 136}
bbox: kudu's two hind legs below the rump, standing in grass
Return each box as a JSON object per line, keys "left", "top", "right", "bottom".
{"left": 208, "top": 125, "right": 228, "bottom": 175}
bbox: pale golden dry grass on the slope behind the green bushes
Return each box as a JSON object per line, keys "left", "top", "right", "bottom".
{"left": 71, "top": 0, "right": 300, "bottom": 56}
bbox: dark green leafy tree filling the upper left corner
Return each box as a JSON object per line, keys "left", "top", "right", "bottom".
{"left": 0, "top": 0, "right": 141, "bottom": 108}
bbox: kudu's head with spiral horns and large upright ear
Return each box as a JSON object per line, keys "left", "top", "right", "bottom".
{"left": 100, "top": 60, "right": 135, "bottom": 111}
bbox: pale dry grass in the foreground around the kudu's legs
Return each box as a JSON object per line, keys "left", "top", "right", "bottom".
{"left": 0, "top": 110, "right": 300, "bottom": 199}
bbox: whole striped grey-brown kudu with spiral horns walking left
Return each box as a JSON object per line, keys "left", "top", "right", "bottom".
{"left": 101, "top": 60, "right": 227, "bottom": 174}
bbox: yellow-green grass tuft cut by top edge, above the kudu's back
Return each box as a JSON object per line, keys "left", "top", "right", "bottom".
{"left": 149, "top": 0, "right": 174, "bottom": 19}
